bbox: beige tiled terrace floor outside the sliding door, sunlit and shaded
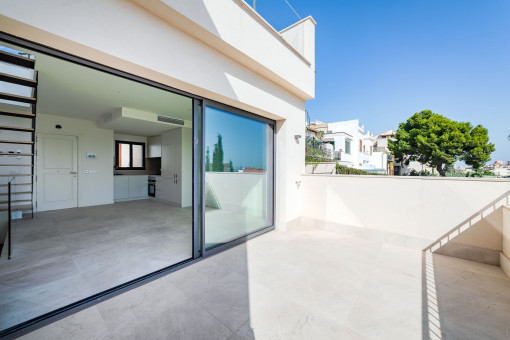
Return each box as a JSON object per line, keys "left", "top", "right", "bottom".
{"left": 15, "top": 230, "right": 510, "bottom": 339}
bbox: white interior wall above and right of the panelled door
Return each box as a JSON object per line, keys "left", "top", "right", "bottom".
{"left": 34, "top": 113, "right": 114, "bottom": 207}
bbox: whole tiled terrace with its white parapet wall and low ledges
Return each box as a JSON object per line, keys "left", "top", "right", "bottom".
{"left": 17, "top": 175, "right": 510, "bottom": 339}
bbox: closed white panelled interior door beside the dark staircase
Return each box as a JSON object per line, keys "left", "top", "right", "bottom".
{"left": 37, "top": 133, "right": 78, "bottom": 211}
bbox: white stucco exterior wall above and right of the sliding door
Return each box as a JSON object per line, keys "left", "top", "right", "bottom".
{"left": 0, "top": 0, "right": 315, "bottom": 229}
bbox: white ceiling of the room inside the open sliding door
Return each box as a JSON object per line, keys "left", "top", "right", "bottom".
{"left": 2, "top": 43, "right": 192, "bottom": 136}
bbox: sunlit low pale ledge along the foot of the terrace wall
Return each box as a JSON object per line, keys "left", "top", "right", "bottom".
{"left": 300, "top": 217, "right": 433, "bottom": 250}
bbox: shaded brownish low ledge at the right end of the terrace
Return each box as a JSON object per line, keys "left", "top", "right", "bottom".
{"left": 434, "top": 242, "right": 500, "bottom": 266}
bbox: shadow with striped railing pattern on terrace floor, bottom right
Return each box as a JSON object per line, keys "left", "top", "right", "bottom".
{"left": 422, "top": 251, "right": 510, "bottom": 339}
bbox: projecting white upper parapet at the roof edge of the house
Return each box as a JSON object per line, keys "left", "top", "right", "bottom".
{"left": 139, "top": 0, "right": 315, "bottom": 99}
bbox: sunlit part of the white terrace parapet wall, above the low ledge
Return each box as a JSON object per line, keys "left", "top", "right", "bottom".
{"left": 300, "top": 175, "right": 510, "bottom": 246}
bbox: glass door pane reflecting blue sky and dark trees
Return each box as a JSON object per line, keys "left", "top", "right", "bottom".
{"left": 204, "top": 103, "right": 274, "bottom": 252}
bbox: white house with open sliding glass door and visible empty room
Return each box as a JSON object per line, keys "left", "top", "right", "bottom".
{"left": 0, "top": 0, "right": 316, "bottom": 336}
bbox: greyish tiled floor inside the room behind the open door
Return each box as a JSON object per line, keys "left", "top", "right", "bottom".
{"left": 0, "top": 199, "right": 192, "bottom": 329}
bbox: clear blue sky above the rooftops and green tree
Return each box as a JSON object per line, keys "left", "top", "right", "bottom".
{"left": 248, "top": 0, "right": 510, "bottom": 165}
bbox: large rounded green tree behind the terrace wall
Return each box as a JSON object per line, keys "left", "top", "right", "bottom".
{"left": 388, "top": 110, "right": 495, "bottom": 176}
